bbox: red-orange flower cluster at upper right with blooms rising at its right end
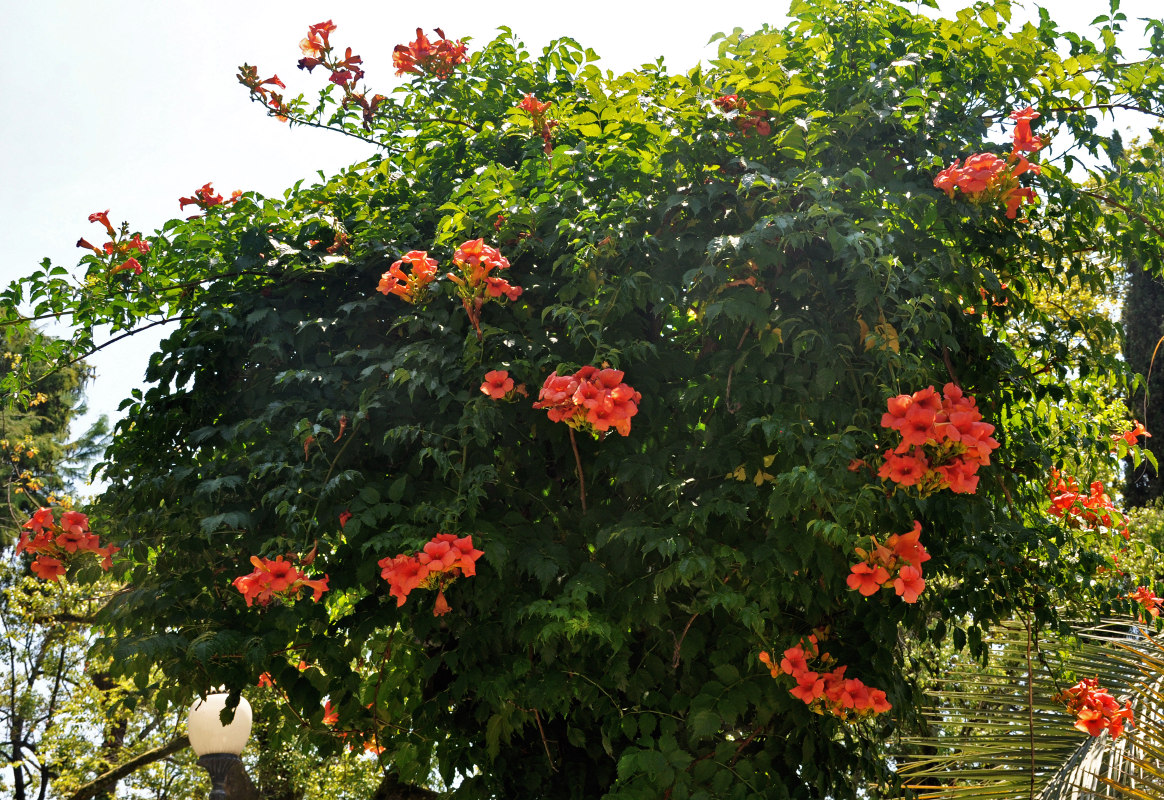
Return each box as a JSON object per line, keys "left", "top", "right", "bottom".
{"left": 934, "top": 107, "right": 1043, "bottom": 219}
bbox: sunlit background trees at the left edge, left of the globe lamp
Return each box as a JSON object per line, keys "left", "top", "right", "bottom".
{"left": 0, "top": 326, "right": 198, "bottom": 800}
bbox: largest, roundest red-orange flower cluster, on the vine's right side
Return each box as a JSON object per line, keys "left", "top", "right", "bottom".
{"left": 878, "top": 383, "right": 999, "bottom": 495}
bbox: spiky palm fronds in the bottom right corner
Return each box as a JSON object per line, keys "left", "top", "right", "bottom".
{"left": 897, "top": 620, "right": 1164, "bottom": 800}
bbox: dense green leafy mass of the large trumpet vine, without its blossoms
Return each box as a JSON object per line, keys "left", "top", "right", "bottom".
{"left": 8, "top": 0, "right": 1164, "bottom": 800}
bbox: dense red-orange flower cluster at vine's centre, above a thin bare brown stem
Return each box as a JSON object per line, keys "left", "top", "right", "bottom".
{"left": 533, "top": 366, "right": 643, "bottom": 437}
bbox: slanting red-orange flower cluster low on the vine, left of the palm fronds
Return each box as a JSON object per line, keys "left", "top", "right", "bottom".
{"left": 760, "top": 636, "right": 893, "bottom": 720}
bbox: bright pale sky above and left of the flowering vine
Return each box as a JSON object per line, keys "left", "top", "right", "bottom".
{"left": 0, "top": 0, "right": 1162, "bottom": 489}
